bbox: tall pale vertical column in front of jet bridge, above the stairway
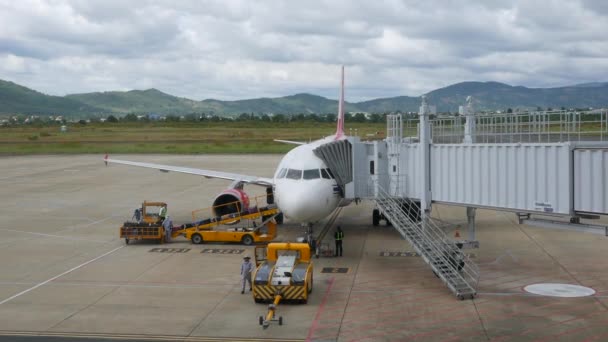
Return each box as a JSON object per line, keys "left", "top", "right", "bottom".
{"left": 418, "top": 95, "right": 431, "bottom": 223}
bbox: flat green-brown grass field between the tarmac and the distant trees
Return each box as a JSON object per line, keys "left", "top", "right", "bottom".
{"left": 0, "top": 122, "right": 385, "bottom": 155}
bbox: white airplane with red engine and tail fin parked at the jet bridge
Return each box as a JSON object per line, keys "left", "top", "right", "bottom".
{"left": 104, "top": 66, "right": 349, "bottom": 227}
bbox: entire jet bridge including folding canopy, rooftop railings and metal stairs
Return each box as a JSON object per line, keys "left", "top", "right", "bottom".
{"left": 332, "top": 97, "right": 608, "bottom": 298}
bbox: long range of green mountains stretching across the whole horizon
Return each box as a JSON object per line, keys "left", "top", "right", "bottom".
{"left": 0, "top": 80, "right": 608, "bottom": 115}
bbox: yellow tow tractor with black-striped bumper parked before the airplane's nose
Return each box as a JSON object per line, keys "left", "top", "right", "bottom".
{"left": 252, "top": 242, "right": 313, "bottom": 329}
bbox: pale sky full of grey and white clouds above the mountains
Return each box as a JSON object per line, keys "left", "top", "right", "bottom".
{"left": 0, "top": 0, "right": 608, "bottom": 101}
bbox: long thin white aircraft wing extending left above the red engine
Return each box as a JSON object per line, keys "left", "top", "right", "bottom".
{"left": 103, "top": 155, "right": 273, "bottom": 186}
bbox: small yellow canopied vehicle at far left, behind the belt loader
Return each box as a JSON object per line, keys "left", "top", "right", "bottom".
{"left": 120, "top": 201, "right": 167, "bottom": 245}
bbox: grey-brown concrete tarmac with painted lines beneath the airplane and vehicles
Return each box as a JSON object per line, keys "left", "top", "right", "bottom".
{"left": 0, "top": 155, "right": 608, "bottom": 342}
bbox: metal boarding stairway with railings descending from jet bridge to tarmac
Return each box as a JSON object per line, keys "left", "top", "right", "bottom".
{"left": 375, "top": 186, "right": 479, "bottom": 299}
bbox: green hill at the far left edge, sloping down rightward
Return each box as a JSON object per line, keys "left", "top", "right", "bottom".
{"left": 0, "top": 80, "right": 100, "bottom": 115}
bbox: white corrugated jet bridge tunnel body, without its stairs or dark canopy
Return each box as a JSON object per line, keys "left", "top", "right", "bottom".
{"left": 345, "top": 100, "right": 608, "bottom": 218}
